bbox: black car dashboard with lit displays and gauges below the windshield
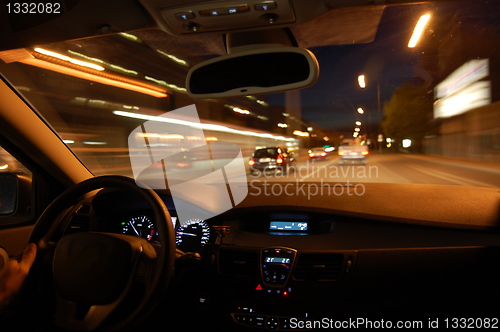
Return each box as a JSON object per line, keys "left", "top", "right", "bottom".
{"left": 66, "top": 190, "right": 500, "bottom": 330}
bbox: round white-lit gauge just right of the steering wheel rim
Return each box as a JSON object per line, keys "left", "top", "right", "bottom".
{"left": 175, "top": 218, "right": 210, "bottom": 252}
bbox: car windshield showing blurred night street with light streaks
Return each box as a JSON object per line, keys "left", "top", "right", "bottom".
{"left": 0, "top": 1, "right": 500, "bottom": 187}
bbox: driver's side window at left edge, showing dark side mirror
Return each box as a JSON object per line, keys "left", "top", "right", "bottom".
{"left": 0, "top": 147, "right": 33, "bottom": 226}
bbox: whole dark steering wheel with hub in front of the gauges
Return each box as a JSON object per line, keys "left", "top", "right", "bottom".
{"left": 29, "top": 175, "right": 175, "bottom": 331}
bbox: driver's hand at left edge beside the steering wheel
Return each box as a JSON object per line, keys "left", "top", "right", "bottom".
{"left": 0, "top": 243, "right": 36, "bottom": 309}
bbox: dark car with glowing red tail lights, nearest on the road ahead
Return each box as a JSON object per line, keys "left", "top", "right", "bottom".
{"left": 248, "top": 146, "right": 296, "bottom": 174}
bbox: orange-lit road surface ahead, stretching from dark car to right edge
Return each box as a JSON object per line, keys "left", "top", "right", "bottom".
{"left": 248, "top": 154, "right": 500, "bottom": 188}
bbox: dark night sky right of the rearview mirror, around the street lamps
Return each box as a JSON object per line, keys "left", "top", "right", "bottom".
{"left": 272, "top": 5, "right": 440, "bottom": 131}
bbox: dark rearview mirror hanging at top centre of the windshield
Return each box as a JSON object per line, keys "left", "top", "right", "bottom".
{"left": 186, "top": 47, "right": 319, "bottom": 98}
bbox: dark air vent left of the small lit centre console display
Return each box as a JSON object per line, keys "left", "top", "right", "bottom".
{"left": 219, "top": 249, "right": 259, "bottom": 277}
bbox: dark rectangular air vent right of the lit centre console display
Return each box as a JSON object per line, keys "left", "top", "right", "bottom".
{"left": 293, "top": 253, "right": 344, "bottom": 281}
